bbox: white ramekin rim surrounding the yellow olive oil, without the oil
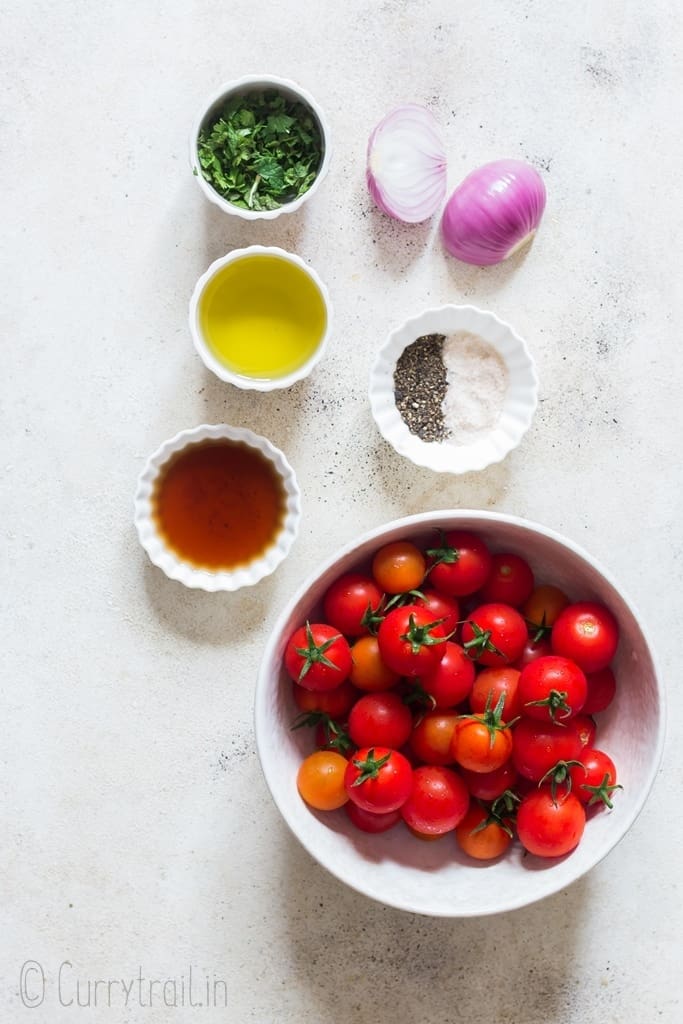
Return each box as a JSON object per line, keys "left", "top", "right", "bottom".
{"left": 189, "top": 246, "right": 332, "bottom": 391}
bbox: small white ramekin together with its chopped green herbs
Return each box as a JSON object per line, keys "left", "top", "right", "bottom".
{"left": 190, "top": 75, "right": 330, "bottom": 220}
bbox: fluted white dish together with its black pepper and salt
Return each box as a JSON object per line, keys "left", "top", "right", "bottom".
{"left": 370, "top": 305, "right": 539, "bottom": 473}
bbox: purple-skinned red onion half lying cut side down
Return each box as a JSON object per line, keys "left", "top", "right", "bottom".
{"left": 441, "top": 160, "right": 546, "bottom": 266}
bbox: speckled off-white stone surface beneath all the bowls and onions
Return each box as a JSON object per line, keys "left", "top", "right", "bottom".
{"left": 0, "top": 0, "right": 683, "bottom": 1024}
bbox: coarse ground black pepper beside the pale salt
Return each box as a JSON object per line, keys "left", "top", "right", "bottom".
{"left": 393, "top": 334, "right": 449, "bottom": 441}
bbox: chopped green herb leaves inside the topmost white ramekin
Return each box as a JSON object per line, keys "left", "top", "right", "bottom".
{"left": 197, "top": 89, "right": 323, "bottom": 210}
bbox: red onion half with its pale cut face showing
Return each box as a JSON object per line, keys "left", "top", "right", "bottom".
{"left": 366, "top": 103, "right": 446, "bottom": 224}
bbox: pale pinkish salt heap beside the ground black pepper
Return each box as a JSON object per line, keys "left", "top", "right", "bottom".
{"left": 441, "top": 331, "right": 509, "bottom": 444}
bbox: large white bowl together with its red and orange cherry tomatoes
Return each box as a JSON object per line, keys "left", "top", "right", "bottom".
{"left": 255, "top": 510, "right": 665, "bottom": 918}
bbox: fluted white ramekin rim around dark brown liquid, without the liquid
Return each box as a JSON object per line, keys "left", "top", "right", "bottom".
{"left": 134, "top": 423, "right": 301, "bottom": 593}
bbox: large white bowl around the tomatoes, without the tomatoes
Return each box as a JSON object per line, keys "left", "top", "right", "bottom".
{"left": 255, "top": 511, "right": 665, "bottom": 918}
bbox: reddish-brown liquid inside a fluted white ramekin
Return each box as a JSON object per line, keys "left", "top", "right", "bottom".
{"left": 153, "top": 440, "right": 286, "bottom": 569}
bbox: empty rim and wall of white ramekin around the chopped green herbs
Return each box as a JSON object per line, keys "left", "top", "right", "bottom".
{"left": 189, "top": 75, "right": 332, "bottom": 220}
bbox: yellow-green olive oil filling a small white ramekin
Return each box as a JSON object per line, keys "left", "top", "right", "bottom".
{"left": 199, "top": 255, "right": 327, "bottom": 380}
